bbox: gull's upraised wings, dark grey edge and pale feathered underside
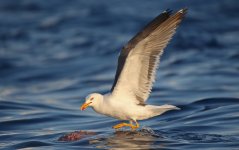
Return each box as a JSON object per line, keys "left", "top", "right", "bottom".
{"left": 111, "top": 9, "right": 186, "bottom": 104}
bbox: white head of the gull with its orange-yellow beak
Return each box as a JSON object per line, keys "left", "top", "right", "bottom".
{"left": 80, "top": 93, "right": 103, "bottom": 110}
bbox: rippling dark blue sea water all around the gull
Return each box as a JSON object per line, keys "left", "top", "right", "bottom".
{"left": 0, "top": 0, "right": 239, "bottom": 150}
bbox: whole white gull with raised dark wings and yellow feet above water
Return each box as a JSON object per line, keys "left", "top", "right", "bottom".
{"left": 81, "top": 9, "right": 187, "bottom": 130}
